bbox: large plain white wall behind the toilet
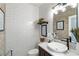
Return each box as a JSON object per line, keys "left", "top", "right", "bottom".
{"left": 5, "top": 4, "right": 39, "bottom": 56}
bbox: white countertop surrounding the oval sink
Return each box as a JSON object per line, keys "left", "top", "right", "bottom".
{"left": 38, "top": 42, "right": 79, "bottom": 56}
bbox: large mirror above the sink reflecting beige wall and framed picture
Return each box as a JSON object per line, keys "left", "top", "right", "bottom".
{"left": 53, "top": 5, "right": 78, "bottom": 40}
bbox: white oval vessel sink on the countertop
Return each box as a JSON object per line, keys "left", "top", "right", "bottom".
{"left": 47, "top": 42, "right": 67, "bottom": 53}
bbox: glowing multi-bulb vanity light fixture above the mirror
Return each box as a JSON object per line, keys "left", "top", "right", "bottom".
{"left": 52, "top": 3, "right": 77, "bottom": 14}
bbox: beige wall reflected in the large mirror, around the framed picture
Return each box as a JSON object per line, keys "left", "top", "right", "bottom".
{"left": 53, "top": 6, "right": 76, "bottom": 39}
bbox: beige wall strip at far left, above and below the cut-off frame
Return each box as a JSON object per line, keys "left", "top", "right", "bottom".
{"left": 0, "top": 3, "right": 5, "bottom": 55}
